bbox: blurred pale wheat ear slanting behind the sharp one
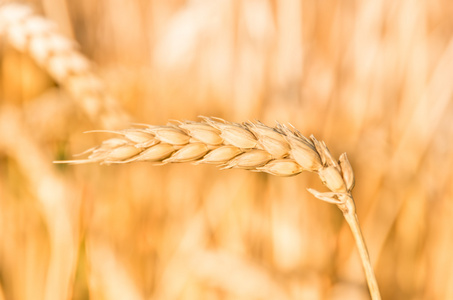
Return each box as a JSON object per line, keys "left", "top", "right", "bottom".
{"left": 0, "top": 2, "right": 128, "bottom": 128}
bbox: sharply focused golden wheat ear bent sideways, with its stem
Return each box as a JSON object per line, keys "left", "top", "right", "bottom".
{"left": 57, "top": 117, "right": 380, "bottom": 300}
